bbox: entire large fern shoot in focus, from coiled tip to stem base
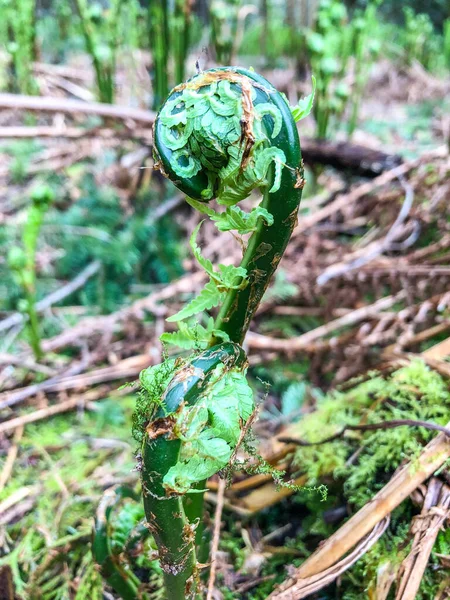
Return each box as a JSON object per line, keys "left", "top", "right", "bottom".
{"left": 92, "top": 67, "right": 311, "bottom": 600}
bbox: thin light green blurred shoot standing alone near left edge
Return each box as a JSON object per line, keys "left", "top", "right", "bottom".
{"left": 8, "top": 185, "right": 54, "bottom": 359}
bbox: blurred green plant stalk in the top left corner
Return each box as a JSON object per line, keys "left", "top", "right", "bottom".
{"left": 0, "top": 0, "right": 37, "bottom": 94}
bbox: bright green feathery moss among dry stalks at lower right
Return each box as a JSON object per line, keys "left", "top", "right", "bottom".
{"left": 295, "top": 360, "right": 450, "bottom": 600}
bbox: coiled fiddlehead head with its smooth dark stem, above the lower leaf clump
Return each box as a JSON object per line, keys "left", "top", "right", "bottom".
{"left": 155, "top": 67, "right": 303, "bottom": 343}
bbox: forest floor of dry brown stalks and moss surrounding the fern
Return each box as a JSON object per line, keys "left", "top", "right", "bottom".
{"left": 0, "top": 54, "right": 450, "bottom": 600}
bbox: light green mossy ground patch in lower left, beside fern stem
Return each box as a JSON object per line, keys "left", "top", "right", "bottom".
{"left": 0, "top": 397, "right": 138, "bottom": 600}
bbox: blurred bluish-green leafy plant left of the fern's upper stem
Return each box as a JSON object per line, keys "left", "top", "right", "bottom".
{"left": 43, "top": 175, "right": 183, "bottom": 313}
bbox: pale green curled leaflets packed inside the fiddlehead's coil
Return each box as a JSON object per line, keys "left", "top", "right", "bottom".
{"left": 158, "top": 73, "right": 286, "bottom": 206}
